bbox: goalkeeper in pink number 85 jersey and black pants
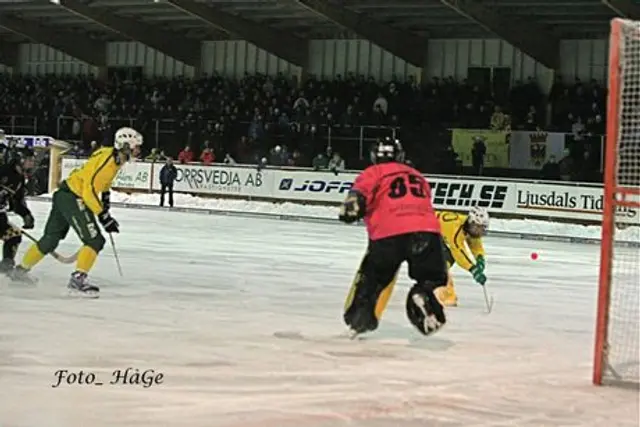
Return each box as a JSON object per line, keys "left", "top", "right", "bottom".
{"left": 339, "top": 138, "right": 447, "bottom": 335}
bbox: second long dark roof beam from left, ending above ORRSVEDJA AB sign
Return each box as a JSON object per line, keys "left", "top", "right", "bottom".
{"left": 55, "top": 0, "right": 202, "bottom": 67}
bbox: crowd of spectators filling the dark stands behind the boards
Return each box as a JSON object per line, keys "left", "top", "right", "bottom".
{"left": 0, "top": 71, "right": 606, "bottom": 181}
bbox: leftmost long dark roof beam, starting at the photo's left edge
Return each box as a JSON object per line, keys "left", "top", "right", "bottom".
{"left": 0, "top": 14, "right": 107, "bottom": 67}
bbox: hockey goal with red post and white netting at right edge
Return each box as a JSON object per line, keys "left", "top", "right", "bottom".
{"left": 593, "top": 19, "right": 640, "bottom": 387}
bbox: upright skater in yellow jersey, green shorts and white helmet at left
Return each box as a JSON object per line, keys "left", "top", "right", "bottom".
{"left": 12, "top": 127, "right": 142, "bottom": 296}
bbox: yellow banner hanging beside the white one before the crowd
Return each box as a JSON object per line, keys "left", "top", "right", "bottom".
{"left": 451, "top": 129, "right": 509, "bottom": 168}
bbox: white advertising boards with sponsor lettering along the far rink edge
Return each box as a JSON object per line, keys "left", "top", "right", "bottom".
{"left": 61, "top": 158, "right": 640, "bottom": 225}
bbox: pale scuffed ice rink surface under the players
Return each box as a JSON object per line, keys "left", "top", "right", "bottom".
{"left": 0, "top": 202, "right": 639, "bottom": 427}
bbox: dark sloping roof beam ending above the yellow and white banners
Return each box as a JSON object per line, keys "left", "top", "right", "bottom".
{"left": 440, "top": 0, "right": 560, "bottom": 70}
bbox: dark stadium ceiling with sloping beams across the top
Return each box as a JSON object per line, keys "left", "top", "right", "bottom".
{"left": 0, "top": 0, "right": 640, "bottom": 69}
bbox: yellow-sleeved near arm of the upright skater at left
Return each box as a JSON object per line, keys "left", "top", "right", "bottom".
{"left": 82, "top": 150, "right": 118, "bottom": 215}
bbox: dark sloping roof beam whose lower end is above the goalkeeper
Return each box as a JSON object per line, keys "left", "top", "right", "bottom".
{"left": 296, "top": 0, "right": 429, "bottom": 68}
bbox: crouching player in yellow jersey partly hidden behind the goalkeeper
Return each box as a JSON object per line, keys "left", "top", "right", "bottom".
{"left": 436, "top": 207, "right": 489, "bottom": 307}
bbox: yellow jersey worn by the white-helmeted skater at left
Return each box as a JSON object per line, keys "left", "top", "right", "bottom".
{"left": 65, "top": 147, "right": 120, "bottom": 215}
